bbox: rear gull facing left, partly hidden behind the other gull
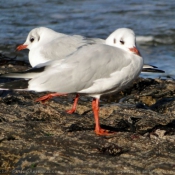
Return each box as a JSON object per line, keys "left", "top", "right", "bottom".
{"left": 17, "top": 27, "right": 164, "bottom": 110}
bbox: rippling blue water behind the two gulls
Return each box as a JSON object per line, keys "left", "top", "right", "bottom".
{"left": 0, "top": 0, "right": 175, "bottom": 78}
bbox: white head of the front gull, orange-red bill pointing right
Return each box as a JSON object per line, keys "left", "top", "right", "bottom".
{"left": 106, "top": 28, "right": 140, "bottom": 56}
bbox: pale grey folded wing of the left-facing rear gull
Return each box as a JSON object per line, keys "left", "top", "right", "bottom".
{"left": 40, "top": 35, "right": 104, "bottom": 60}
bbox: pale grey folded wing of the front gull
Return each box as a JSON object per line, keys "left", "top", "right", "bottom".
{"left": 29, "top": 44, "right": 134, "bottom": 93}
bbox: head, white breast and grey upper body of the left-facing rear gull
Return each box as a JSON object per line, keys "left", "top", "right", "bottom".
{"left": 17, "top": 27, "right": 103, "bottom": 67}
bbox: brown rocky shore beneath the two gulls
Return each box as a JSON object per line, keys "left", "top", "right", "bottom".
{"left": 0, "top": 59, "right": 175, "bottom": 175}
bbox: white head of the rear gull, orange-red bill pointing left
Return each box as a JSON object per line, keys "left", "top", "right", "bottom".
{"left": 17, "top": 27, "right": 58, "bottom": 50}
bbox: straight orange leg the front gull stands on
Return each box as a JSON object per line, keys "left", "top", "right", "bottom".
{"left": 92, "top": 98, "right": 114, "bottom": 135}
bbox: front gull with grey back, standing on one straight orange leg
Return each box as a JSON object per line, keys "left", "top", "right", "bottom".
{"left": 0, "top": 28, "right": 143, "bottom": 135}
